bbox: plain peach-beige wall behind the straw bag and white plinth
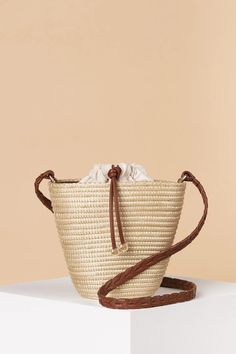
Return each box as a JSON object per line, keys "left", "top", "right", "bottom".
{"left": 0, "top": 0, "right": 236, "bottom": 283}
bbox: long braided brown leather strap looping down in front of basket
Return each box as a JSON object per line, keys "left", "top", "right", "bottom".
{"left": 98, "top": 171, "right": 208, "bottom": 309}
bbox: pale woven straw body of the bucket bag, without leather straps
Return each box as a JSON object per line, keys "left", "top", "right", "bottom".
{"left": 49, "top": 180, "right": 186, "bottom": 299}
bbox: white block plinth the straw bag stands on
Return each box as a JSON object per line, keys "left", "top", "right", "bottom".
{"left": 0, "top": 278, "right": 236, "bottom": 354}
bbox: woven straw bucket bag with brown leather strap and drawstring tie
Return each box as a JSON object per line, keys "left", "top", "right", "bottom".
{"left": 35, "top": 165, "right": 208, "bottom": 309}
